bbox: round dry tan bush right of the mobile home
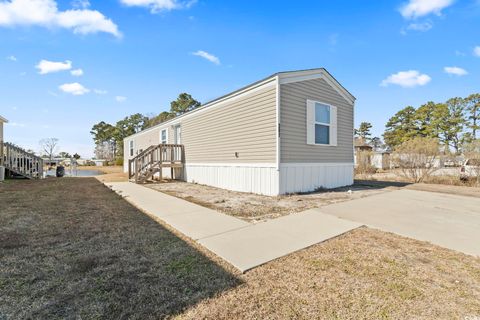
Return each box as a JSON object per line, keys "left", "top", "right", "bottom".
{"left": 392, "top": 137, "right": 440, "bottom": 182}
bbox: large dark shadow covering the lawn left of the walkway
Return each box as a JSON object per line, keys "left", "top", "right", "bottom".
{"left": 0, "top": 178, "right": 241, "bottom": 319}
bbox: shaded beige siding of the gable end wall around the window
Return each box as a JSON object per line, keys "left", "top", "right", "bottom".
{"left": 280, "top": 79, "right": 353, "bottom": 163}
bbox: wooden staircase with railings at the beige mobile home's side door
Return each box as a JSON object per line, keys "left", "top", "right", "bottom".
{"left": 128, "top": 144, "right": 185, "bottom": 183}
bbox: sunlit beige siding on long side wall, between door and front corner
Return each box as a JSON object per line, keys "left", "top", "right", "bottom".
{"left": 181, "top": 83, "right": 276, "bottom": 163}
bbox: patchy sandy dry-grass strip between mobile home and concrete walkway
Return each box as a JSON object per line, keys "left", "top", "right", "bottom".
{"left": 146, "top": 181, "right": 396, "bottom": 222}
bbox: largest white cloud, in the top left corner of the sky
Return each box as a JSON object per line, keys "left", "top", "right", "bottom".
{"left": 0, "top": 0, "right": 121, "bottom": 37}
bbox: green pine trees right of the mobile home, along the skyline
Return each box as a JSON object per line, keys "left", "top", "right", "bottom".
{"left": 355, "top": 93, "right": 480, "bottom": 154}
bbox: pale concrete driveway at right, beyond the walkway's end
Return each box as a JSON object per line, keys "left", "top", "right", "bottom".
{"left": 316, "top": 189, "right": 480, "bottom": 256}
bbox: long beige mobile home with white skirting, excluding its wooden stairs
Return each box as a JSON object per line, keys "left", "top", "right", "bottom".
{"left": 124, "top": 68, "right": 355, "bottom": 195}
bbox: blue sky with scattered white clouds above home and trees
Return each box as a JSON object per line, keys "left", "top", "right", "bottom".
{"left": 0, "top": 0, "right": 480, "bottom": 157}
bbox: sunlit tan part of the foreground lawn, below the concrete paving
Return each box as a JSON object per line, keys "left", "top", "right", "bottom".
{"left": 179, "top": 228, "right": 480, "bottom": 319}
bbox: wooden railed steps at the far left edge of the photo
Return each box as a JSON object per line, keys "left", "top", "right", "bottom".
{"left": 0, "top": 142, "right": 43, "bottom": 179}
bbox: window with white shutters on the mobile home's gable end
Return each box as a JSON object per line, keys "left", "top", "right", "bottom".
{"left": 306, "top": 100, "right": 337, "bottom": 146}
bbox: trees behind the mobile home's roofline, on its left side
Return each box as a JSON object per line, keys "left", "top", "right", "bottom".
{"left": 90, "top": 93, "right": 201, "bottom": 164}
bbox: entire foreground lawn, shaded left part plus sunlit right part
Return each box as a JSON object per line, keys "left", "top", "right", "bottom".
{"left": 0, "top": 178, "right": 480, "bottom": 319}
